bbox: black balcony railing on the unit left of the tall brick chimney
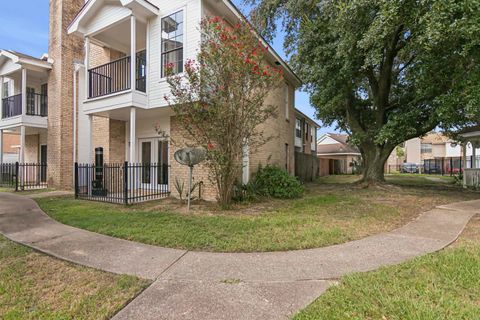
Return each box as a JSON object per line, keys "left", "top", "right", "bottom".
{"left": 2, "top": 93, "right": 48, "bottom": 119}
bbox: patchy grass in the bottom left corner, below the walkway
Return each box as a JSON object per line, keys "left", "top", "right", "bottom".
{"left": 0, "top": 236, "right": 148, "bottom": 320}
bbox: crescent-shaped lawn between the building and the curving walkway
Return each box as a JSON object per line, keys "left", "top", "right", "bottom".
{"left": 37, "top": 176, "right": 478, "bottom": 252}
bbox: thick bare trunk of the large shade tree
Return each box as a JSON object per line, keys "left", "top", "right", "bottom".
{"left": 361, "top": 144, "right": 394, "bottom": 185}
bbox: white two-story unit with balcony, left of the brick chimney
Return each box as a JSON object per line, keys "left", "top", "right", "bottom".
{"left": 0, "top": 50, "right": 52, "bottom": 163}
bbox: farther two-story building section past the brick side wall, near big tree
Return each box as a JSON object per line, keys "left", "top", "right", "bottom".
{"left": 295, "top": 108, "right": 320, "bottom": 154}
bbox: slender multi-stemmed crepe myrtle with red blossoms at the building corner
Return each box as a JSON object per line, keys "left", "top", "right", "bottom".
{"left": 165, "top": 17, "right": 283, "bottom": 206}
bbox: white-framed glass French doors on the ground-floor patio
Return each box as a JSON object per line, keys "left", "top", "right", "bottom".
{"left": 139, "top": 138, "right": 169, "bottom": 187}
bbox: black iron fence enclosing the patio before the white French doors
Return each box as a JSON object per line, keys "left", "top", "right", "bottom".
{"left": 75, "top": 162, "right": 170, "bottom": 204}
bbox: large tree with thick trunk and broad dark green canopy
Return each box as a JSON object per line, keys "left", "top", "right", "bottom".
{"left": 246, "top": 0, "right": 480, "bottom": 184}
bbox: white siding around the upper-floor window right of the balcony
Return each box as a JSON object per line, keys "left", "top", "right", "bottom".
{"left": 147, "top": 0, "right": 201, "bottom": 108}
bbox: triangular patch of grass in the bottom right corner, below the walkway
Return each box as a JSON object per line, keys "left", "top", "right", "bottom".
{"left": 294, "top": 216, "right": 480, "bottom": 320}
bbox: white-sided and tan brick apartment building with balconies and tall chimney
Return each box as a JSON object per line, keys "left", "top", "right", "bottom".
{"left": 0, "top": 0, "right": 308, "bottom": 200}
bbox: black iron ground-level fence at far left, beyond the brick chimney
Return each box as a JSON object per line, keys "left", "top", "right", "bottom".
{"left": 0, "top": 162, "right": 48, "bottom": 191}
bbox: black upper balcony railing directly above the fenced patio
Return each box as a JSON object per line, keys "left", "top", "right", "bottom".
{"left": 88, "top": 51, "right": 146, "bottom": 99}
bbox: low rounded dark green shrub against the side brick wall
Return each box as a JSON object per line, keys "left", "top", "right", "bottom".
{"left": 249, "top": 166, "right": 305, "bottom": 199}
